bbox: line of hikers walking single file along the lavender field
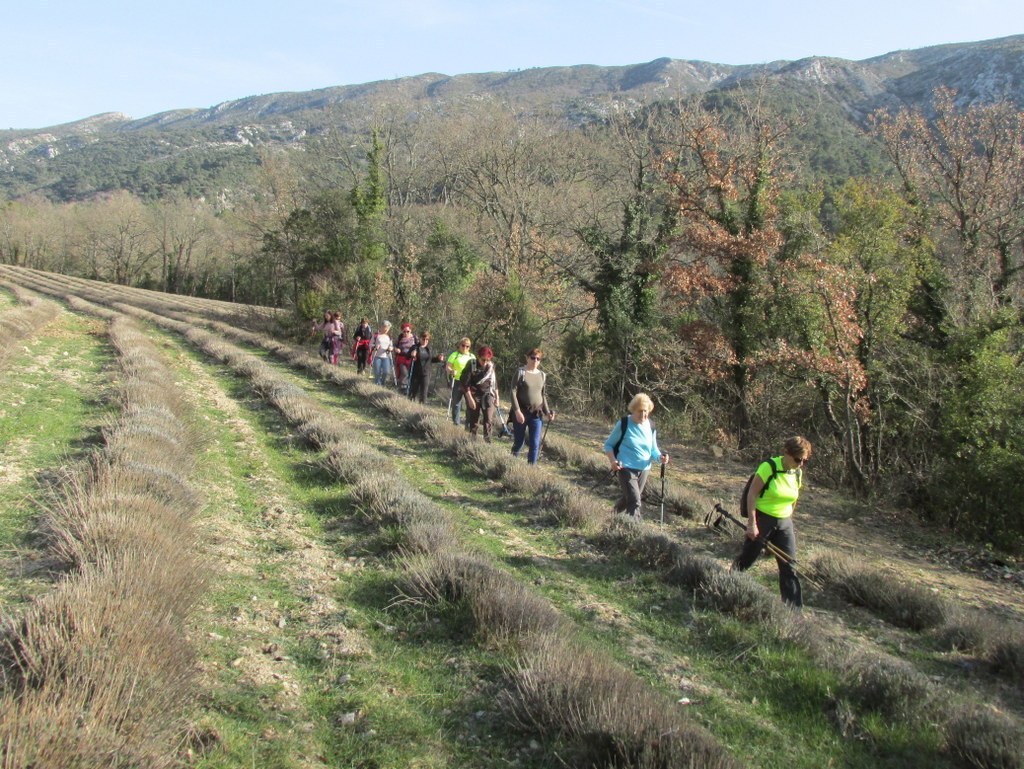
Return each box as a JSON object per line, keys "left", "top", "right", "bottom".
{"left": 313, "top": 312, "right": 812, "bottom": 608}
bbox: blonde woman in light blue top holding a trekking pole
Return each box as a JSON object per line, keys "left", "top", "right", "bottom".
{"left": 604, "top": 392, "right": 669, "bottom": 520}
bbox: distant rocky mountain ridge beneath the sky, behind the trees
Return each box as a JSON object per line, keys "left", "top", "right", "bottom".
{"left": 0, "top": 35, "right": 1024, "bottom": 201}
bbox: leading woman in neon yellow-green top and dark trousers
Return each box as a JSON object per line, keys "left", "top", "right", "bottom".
{"left": 732, "top": 435, "right": 812, "bottom": 608}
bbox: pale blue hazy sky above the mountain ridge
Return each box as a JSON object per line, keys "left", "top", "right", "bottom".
{"left": 0, "top": 0, "right": 1024, "bottom": 128}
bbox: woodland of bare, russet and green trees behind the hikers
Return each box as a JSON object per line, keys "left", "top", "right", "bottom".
{"left": 0, "top": 84, "right": 1024, "bottom": 552}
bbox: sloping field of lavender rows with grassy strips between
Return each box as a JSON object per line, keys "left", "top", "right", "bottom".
{"left": 0, "top": 267, "right": 1024, "bottom": 769}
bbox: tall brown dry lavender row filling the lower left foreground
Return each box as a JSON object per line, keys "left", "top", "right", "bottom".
{"left": 0, "top": 319, "right": 204, "bottom": 769}
